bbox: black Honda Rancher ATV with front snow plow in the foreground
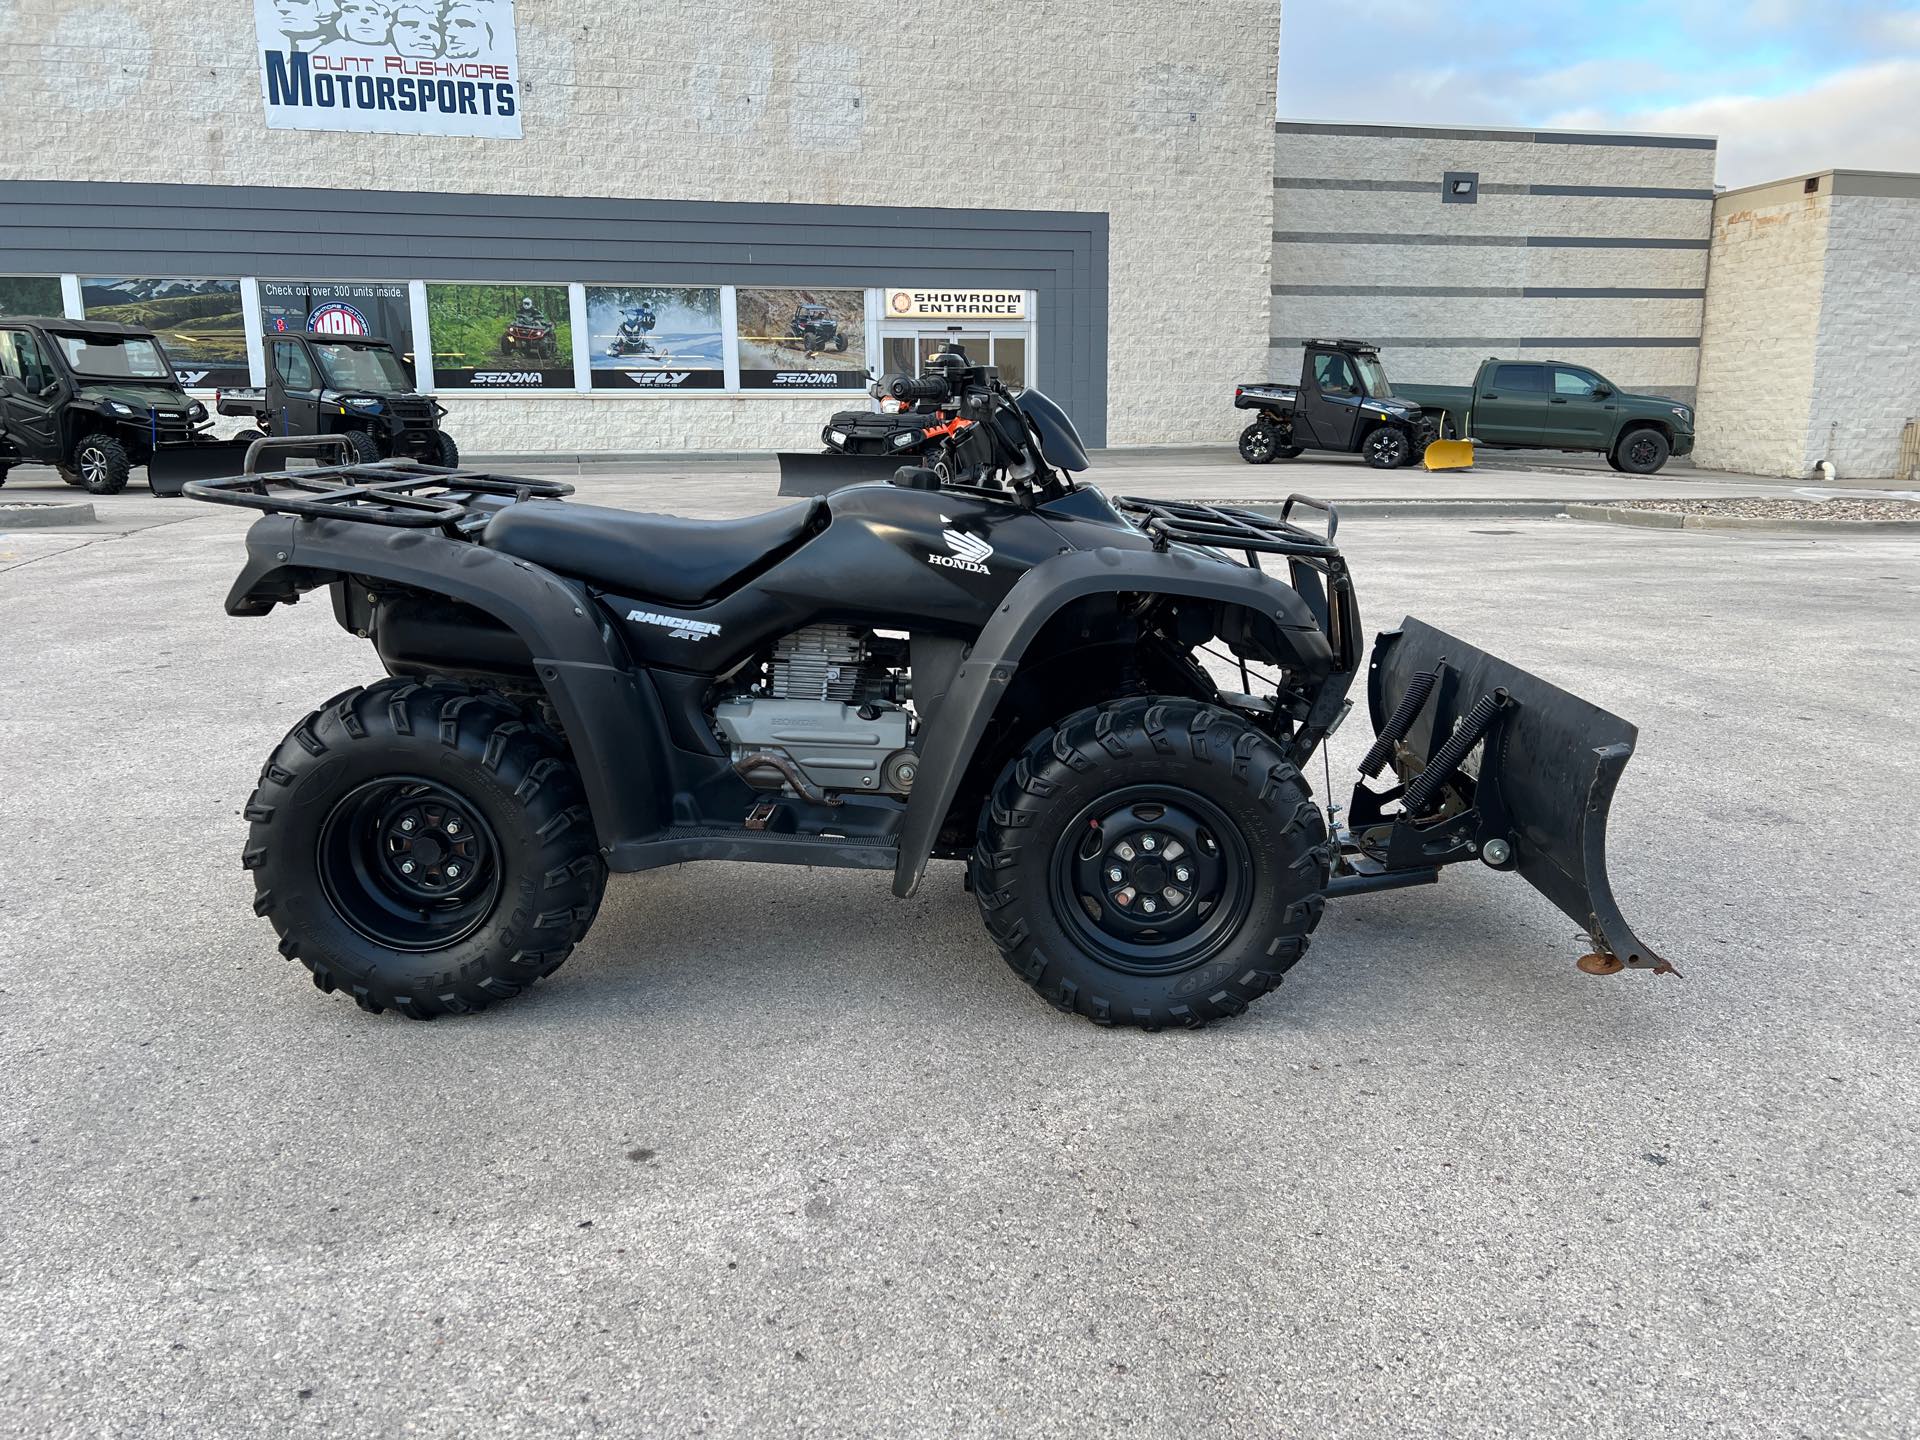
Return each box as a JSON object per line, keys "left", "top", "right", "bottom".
{"left": 190, "top": 378, "right": 1668, "bottom": 1029}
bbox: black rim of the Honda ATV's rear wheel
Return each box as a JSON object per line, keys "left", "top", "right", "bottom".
{"left": 317, "top": 776, "right": 501, "bottom": 950}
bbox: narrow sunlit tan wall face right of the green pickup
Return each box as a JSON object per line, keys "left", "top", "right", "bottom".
{"left": 1693, "top": 179, "right": 1834, "bottom": 476}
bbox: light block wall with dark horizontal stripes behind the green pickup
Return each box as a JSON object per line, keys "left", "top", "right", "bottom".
{"left": 1269, "top": 121, "right": 1715, "bottom": 401}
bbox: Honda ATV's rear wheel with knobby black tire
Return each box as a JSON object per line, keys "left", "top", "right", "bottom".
{"left": 242, "top": 680, "right": 607, "bottom": 1020}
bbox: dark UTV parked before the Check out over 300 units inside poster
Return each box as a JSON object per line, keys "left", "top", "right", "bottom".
{"left": 213, "top": 332, "right": 461, "bottom": 467}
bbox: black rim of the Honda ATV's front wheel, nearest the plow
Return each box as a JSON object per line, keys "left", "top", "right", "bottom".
{"left": 1052, "top": 785, "right": 1254, "bottom": 975}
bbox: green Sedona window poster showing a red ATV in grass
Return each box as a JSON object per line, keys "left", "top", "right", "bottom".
{"left": 426, "top": 284, "right": 574, "bottom": 390}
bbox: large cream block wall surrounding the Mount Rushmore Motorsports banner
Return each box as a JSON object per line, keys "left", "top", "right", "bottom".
{"left": 0, "top": 0, "right": 1279, "bottom": 449}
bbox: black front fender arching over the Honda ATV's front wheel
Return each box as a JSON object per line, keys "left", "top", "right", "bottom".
{"left": 893, "top": 547, "right": 1334, "bottom": 897}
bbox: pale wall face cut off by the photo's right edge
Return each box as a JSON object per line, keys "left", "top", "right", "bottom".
{"left": 1807, "top": 171, "right": 1920, "bottom": 480}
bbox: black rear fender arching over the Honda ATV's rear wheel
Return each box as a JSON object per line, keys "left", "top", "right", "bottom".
{"left": 227, "top": 515, "right": 668, "bottom": 852}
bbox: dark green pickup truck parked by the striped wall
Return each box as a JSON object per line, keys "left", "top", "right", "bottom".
{"left": 1394, "top": 359, "right": 1693, "bottom": 474}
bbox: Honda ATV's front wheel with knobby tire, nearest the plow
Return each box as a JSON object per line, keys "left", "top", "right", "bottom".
{"left": 972, "top": 699, "right": 1329, "bottom": 1029}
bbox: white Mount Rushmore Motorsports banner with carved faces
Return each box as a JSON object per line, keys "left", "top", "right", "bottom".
{"left": 253, "top": 0, "right": 520, "bottom": 140}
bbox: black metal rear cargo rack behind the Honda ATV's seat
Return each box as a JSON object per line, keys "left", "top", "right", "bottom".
{"left": 182, "top": 436, "right": 574, "bottom": 536}
